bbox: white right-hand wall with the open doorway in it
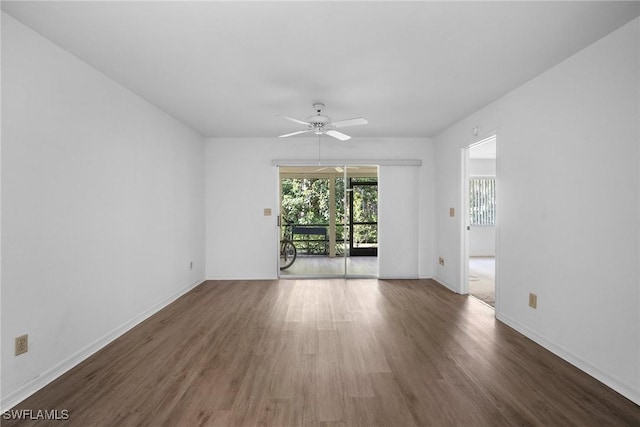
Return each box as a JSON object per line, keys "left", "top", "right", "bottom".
{"left": 434, "top": 19, "right": 640, "bottom": 404}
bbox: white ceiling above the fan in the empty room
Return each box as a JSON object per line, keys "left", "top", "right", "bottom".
{"left": 2, "top": 1, "right": 640, "bottom": 137}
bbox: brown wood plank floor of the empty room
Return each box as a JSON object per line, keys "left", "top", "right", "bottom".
{"left": 3, "top": 279, "right": 640, "bottom": 426}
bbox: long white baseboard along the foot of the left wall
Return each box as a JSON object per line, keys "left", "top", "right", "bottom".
{"left": 0, "top": 280, "right": 203, "bottom": 413}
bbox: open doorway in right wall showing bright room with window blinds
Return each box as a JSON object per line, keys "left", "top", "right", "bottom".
{"left": 463, "top": 135, "right": 497, "bottom": 308}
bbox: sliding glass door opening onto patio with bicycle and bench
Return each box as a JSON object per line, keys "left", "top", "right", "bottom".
{"left": 278, "top": 165, "right": 378, "bottom": 278}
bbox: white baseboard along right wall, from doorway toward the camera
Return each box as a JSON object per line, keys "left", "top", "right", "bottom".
{"left": 496, "top": 313, "right": 640, "bottom": 405}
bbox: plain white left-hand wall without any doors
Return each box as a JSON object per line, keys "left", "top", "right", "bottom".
{"left": 2, "top": 13, "right": 204, "bottom": 409}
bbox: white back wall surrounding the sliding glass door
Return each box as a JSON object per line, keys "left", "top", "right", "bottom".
{"left": 206, "top": 136, "right": 433, "bottom": 279}
